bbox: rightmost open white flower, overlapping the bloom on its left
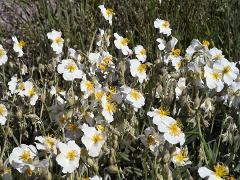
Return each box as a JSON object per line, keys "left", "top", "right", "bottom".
{"left": 213, "top": 59, "right": 239, "bottom": 85}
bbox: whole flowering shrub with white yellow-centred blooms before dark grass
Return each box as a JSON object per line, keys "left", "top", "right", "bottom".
{"left": 0, "top": 1, "right": 240, "bottom": 180}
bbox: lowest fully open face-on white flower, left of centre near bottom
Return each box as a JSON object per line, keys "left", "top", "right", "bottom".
{"left": 56, "top": 141, "right": 81, "bottom": 173}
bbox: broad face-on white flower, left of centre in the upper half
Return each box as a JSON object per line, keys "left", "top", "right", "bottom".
{"left": 57, "top": 59, "right": 83, "bottom": 81}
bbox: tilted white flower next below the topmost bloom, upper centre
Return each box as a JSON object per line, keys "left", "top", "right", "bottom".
{"left": 114, "top": 33, "right": 132, "bottom": 55}
